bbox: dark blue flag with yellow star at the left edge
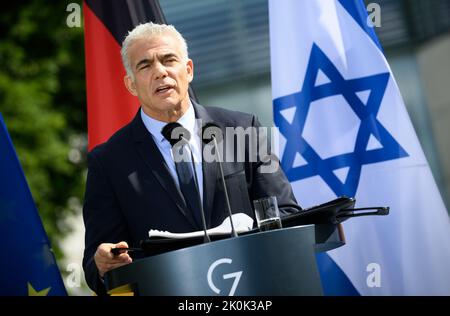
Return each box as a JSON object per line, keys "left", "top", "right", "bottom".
{"left": 0, "top": 114, "right": 67, "bottom": 296}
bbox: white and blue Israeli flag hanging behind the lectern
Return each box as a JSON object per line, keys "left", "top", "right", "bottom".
{"left": 269, "top": 0, "right": 450, "bottom": 295}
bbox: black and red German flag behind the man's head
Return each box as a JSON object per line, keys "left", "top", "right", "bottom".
{"left": 83, "top": 0, "right": 166, "bottom": 150}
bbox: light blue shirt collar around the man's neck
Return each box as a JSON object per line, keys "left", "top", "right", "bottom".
{"left": 141, "top": 102, "right": 195, "bottom": 143}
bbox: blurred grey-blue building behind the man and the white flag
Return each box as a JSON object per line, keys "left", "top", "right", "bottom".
{"left": 160, "top": 0, "right": 450, "bottom": 209}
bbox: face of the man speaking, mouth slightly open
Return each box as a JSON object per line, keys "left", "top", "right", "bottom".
{"left": 125, "top": 35, "right": 193, "bottom": 121}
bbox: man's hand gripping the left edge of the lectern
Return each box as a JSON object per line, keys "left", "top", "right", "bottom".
{"left": 94, "top": 241, "right": 133, "bottom": 277}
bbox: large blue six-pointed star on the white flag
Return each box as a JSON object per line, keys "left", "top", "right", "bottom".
{"left": 273, "top": 44, "right": 408, "bottom": 196}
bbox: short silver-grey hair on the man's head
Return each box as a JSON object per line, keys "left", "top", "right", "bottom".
{"left": 120, "top": 22, "right": 189, "bottom": 80}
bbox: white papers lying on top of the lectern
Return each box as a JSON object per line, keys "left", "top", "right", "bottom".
{"left": 148, "top": 213, "right": 253, "bottom": 239}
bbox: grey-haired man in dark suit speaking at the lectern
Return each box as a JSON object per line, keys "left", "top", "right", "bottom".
{"left": 83, "top": 23, "right": 296, "bottom": 295}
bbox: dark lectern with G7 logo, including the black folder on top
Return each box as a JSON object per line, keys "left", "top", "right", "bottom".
{"left": 105, "top": 197, "right": 389, "bottom": 296}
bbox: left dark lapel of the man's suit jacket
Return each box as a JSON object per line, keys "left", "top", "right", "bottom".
{"left": 132, "top": 110, "right": 198, "bottom": 228}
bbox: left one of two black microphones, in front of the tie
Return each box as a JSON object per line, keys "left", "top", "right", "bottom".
{"left": 161, "top": 122, "right": 211, "bottom": 242}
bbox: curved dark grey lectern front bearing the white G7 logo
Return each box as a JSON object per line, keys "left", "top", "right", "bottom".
{"left": 105, "top": 225, "right": 343, "bottom": 296}
